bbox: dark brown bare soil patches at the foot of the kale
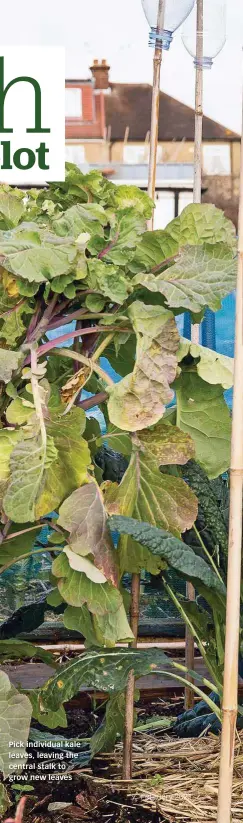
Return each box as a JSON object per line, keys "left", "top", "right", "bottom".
{"left": 4, "top": 697, "right": 183, "bottom": 823}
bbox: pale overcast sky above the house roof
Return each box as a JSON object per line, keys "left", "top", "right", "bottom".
{"left": 1, "top": 0, "right": 243, "bottom": 131}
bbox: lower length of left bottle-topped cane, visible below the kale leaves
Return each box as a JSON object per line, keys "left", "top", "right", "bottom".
{"left": 122, "top": 574, "right": 140, "bottom": 780}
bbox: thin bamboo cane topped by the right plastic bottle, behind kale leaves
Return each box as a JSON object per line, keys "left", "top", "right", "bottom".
{"left": 185, "top": 0, "right": 203, "bottom": 709}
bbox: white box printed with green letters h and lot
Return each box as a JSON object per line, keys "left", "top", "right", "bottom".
{"left": 0, "top": 46, "right": 65, "bottom": 186}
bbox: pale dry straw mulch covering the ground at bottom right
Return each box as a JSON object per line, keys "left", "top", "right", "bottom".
{"left": 88, "top": 733, "right": 243, "bottom": 823}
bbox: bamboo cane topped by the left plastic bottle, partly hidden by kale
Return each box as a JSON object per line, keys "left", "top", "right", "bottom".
{"left": 122, "top": 0, "right": 166, "bottom": 780}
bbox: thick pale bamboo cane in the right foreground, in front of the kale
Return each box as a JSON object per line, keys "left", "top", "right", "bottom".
{"left": 217, "top": 75, "right": 243, "bottom": 823}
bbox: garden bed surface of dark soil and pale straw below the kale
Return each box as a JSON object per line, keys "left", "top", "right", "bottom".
{"left": 7, "top": 733, "right": 243, "bottom": 823}
